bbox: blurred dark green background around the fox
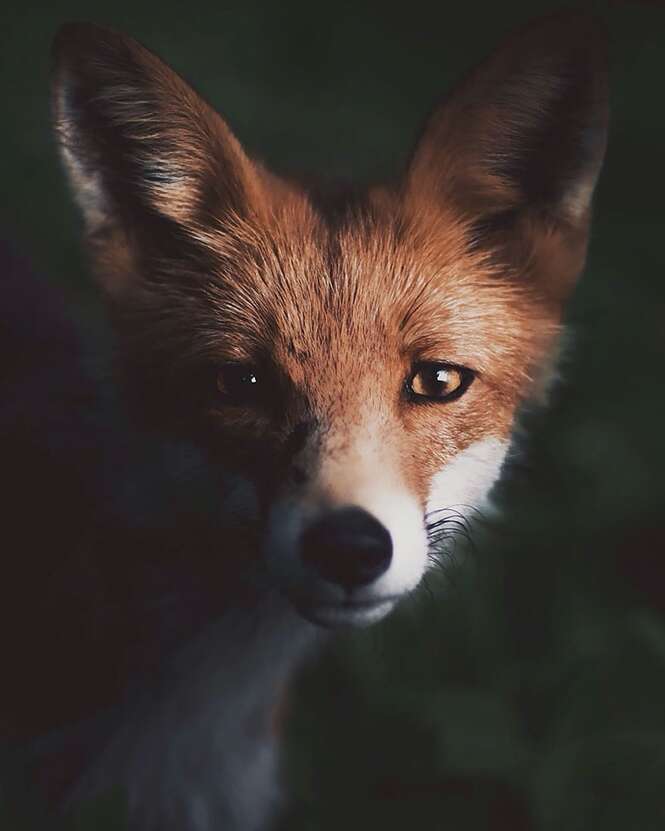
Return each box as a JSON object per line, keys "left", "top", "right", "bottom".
{"left": 0, "top": 0, "right": 665, "bottom": 831}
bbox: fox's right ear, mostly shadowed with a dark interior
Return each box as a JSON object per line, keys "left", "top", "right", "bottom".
{"left": 407, "top": 12, "right": 608, "bottom": 237}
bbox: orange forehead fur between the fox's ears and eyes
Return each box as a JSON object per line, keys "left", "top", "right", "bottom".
{"left": 180, "top": 184, "right": 555, "bottom": 392}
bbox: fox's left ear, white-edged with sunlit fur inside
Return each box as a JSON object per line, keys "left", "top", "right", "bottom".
{"left": 53, "top": 23, "right": 259, "bottom": 234}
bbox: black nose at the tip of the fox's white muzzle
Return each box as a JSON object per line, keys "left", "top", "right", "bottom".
{"left": 302, "top": 508, "right": 393, "bottom": 589}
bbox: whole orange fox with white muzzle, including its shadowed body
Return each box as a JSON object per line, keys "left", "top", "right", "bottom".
{"left": 1, "top": 12, "right": 608, "bottom": 831}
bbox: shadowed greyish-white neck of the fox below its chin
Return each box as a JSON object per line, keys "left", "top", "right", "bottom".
{"left": 71, "top": 588, "right": 322, "bottom": 831}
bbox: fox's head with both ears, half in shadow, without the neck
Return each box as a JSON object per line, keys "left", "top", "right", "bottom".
{"left": 53, "top": 15, "right": 607, "bottom": 625}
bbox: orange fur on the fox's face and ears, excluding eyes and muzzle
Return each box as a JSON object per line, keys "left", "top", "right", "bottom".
{"left": 55, "top": 18, "right": 606, "bottom": 508}
